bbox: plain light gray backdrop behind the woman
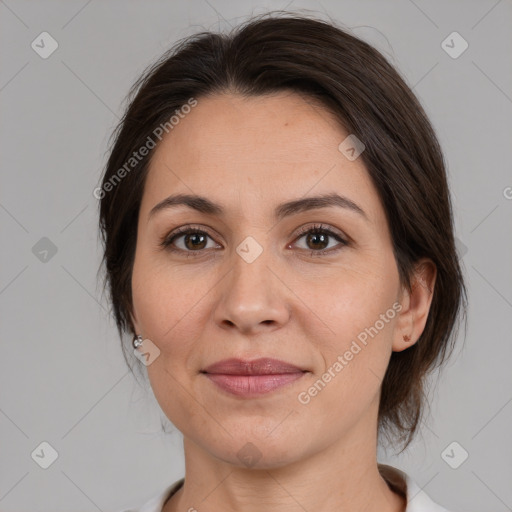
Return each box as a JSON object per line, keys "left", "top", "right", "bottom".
{"left": 0, "top": 0, "right": 512, "bottom": 512}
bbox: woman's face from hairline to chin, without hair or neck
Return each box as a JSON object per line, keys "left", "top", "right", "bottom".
{"left": 132, "top": 93, "right": 423, "bottom": 467}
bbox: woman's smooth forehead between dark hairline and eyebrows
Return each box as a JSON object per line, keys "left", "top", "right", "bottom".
{"left": 143, "top": 92, "right": 382, "bottom": 226}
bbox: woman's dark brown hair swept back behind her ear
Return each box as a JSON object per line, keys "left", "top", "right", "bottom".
{"left": 95, "top": 11, "right": 467, "bottom": 451}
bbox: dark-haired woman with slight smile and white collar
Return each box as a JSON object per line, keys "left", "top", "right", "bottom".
{"left": 95, "top": 13, "right": 466, "bottom": 512}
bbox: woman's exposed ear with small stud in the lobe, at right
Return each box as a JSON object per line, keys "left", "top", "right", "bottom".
{"left": 393, "top": 258, "right": 437, "bottom": 352}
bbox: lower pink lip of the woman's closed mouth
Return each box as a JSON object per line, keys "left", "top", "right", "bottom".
{"left": 205, "top": 372, "right": 304, "bottom": 398}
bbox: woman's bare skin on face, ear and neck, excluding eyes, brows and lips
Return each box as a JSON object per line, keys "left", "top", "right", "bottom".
{"left": 132, "top": 92, "right": 436, "bottom": 512}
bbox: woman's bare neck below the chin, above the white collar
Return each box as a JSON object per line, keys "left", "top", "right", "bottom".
{"left": 163, "top": 400, "right": 406, "bottom": 512}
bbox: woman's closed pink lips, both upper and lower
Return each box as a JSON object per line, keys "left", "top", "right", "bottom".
{"left": 201, "top": 358, "right": 307, "bottom": 398}
